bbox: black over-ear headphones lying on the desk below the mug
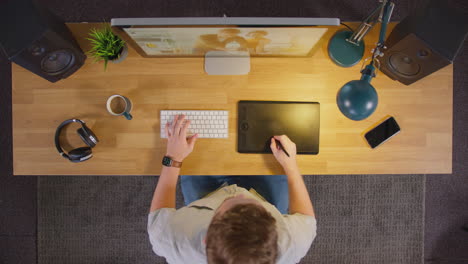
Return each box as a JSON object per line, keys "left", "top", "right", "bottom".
{"left": 55, "top": 119, "right": 99, "bottom": 162}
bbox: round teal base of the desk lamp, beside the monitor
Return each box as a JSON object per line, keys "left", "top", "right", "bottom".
{"left": 328, "top": 30, "right": 365, "bottom": 67}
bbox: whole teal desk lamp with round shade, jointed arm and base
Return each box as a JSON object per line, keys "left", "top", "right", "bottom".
{"left": 329, "top": 0, "right": 395, "bottom": 121}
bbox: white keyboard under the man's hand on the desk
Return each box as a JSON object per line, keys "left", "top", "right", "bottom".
{"left": 160, "top": 110, "right": 229, "bottom": 138}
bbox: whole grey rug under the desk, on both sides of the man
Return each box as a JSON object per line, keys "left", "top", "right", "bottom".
{"left": 38, "top": 175, "right": 424, "bottom": 264}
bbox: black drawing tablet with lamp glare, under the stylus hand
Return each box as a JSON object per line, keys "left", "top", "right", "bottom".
{"left": 237, "top": 101, "right": 320, "bottom": 154}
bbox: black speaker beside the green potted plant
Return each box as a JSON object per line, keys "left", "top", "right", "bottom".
{"left": 0, "top": 0, "right": 86, "bottom": 82}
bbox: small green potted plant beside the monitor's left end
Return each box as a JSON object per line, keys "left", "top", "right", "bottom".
{"left": 87, "top": 26, "right": 128, "bottom": 70}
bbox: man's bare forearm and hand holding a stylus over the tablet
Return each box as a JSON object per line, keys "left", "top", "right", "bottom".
{"left": 270, "top": 135, "right": 315, "bottom": 216}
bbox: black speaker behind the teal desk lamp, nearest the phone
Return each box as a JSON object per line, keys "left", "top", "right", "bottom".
{"left": 380, "top": 0, "right": 468, "bottom": 85}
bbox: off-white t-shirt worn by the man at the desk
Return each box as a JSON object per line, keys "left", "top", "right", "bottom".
{"left": 148, "top": 184, "right": 317, "bottom": 264}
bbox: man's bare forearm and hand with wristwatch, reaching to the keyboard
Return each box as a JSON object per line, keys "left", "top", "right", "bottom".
{"left": 150, "top": 115, "right": 197, "bottom": 212}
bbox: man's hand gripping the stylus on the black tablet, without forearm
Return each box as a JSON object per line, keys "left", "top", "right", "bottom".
{"left": 270, "top": 135, "right": 297, "bottom": 171}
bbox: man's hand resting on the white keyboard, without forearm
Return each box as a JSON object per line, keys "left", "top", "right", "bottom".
{"left": 166, "top": 115, "right": 198, "bottom": 162}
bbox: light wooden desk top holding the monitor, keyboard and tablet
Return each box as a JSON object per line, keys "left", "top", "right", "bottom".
{"left": 12, "top": 24, "right": 453, "bottom": 175}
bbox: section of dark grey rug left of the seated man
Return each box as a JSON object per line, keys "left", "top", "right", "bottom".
{"left": 37, "top": 176, "right": 165, "bottom": 264}
